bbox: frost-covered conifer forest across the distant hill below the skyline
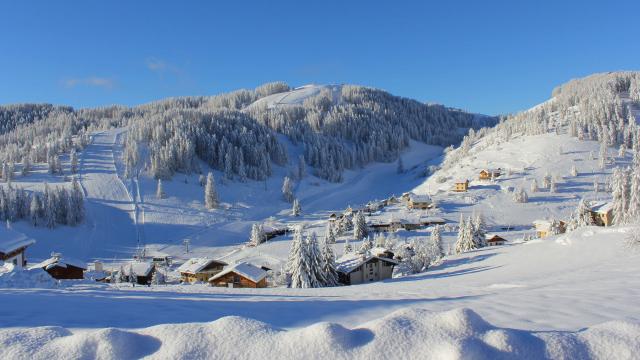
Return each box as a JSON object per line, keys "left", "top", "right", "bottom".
{"left": 0, "top": 82, "right": 495, "bottom": 182}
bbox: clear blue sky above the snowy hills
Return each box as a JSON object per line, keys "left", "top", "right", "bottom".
{"left": 0, "top": 0, "right": 640, "bottom": 114}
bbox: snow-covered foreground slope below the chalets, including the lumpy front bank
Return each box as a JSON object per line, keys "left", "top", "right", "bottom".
{"left": 0, "top": 227, "right": 640, "bottom": 358}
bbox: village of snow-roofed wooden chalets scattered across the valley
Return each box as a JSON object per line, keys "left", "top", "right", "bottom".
{"left": 0, "top": 168, "right": 612, "bottom": 288}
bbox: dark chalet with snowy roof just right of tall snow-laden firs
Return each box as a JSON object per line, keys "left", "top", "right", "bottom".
{"left": 336, "top": 252, "right": 398, "bottom": 285}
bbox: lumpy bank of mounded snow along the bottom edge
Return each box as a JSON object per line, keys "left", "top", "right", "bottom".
{"left": 0, "top": 309, "right": 640, "bottom": 359}
